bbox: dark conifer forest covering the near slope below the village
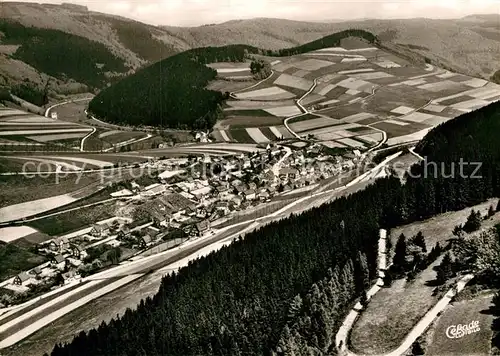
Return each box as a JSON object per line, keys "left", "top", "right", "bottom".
{"left": 52, "top": 103, "right": 500, "bottom": 356}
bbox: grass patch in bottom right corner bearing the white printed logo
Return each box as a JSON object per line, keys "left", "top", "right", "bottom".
{"left": 425, "top": 295, "right": 494, "bottom": 356}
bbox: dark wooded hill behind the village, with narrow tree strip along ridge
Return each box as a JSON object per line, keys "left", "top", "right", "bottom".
{"left": 85, "top": 30, "right": 376, "bottom": 129}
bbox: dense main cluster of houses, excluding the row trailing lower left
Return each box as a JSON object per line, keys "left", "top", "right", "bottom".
{"left": 124, "top": 145, "right": 361, "bottom": 236}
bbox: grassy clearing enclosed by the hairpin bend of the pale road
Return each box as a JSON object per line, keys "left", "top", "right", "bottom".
{"left": 350, "top": 258, "right": 441, "bottom": 355}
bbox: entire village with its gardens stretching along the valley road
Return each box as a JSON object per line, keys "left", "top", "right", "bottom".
{"left": 0, "top": 143, "right": 366, "bottom": 307}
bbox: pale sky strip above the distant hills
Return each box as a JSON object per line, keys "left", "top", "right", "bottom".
{"left": 13, "top": 0, "right": 500, "bottom": 26}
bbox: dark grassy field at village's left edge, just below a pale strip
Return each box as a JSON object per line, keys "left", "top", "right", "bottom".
{"left": 27, "top": 202, "right": 115, "bottom": 236}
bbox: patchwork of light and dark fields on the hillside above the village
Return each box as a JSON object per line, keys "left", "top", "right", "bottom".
{"left": 214, "top": 40, "right": 500, "bottom": 149}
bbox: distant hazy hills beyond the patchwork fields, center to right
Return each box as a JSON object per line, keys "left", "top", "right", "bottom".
{"left": 169, "top": 15, "right": 500, "bottom": 78}
